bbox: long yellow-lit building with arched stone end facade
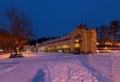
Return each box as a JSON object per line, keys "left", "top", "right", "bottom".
{"left": 38, "top": 24, "right": 97, "bottom": 54}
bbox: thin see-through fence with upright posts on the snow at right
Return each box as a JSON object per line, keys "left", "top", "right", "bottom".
{"left": 89, "top": 53, "right": 120, "bottom": 82}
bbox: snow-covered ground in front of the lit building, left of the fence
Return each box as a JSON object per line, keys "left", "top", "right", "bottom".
{"left": 0, "top": 53, "right": 112, "bottom": 82}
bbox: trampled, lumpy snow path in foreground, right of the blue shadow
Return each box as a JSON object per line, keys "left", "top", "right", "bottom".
{"left": 44, "top": 59, "right": 99, "bottom": 82}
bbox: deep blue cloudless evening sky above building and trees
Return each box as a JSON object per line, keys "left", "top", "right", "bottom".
{"left": 0, "top": 0, "right": 120, "bottom": 37}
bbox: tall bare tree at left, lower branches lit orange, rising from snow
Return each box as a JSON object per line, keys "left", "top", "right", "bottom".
{"left": 0, "top": 7, "right": 32, "bottom": 54}
